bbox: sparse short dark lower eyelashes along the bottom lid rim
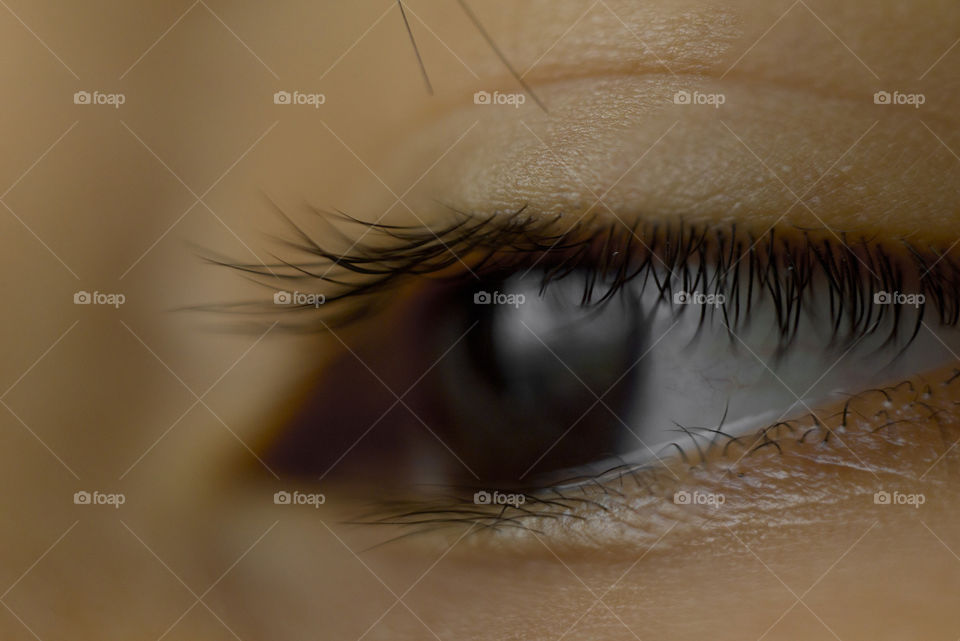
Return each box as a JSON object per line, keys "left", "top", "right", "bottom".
{"left": 350, "top": 369, "right": 960, "bottom": 545}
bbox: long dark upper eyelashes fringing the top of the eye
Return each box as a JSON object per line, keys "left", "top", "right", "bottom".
{"left": 213, "top": 209, "right": 960, "bottom": 347}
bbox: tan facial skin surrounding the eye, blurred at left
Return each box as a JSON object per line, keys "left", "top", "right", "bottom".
{"left": 0, "top": 0, "right": 960, "bottom": 640}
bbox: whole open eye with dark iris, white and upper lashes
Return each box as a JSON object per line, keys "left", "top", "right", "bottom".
{"left": 227, "top": 212, "right": 960, "bottom": 540}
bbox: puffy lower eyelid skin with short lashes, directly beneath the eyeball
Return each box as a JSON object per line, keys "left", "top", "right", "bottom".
{"left": 359, "top": 366, "right": 960, "bottom": 555}
